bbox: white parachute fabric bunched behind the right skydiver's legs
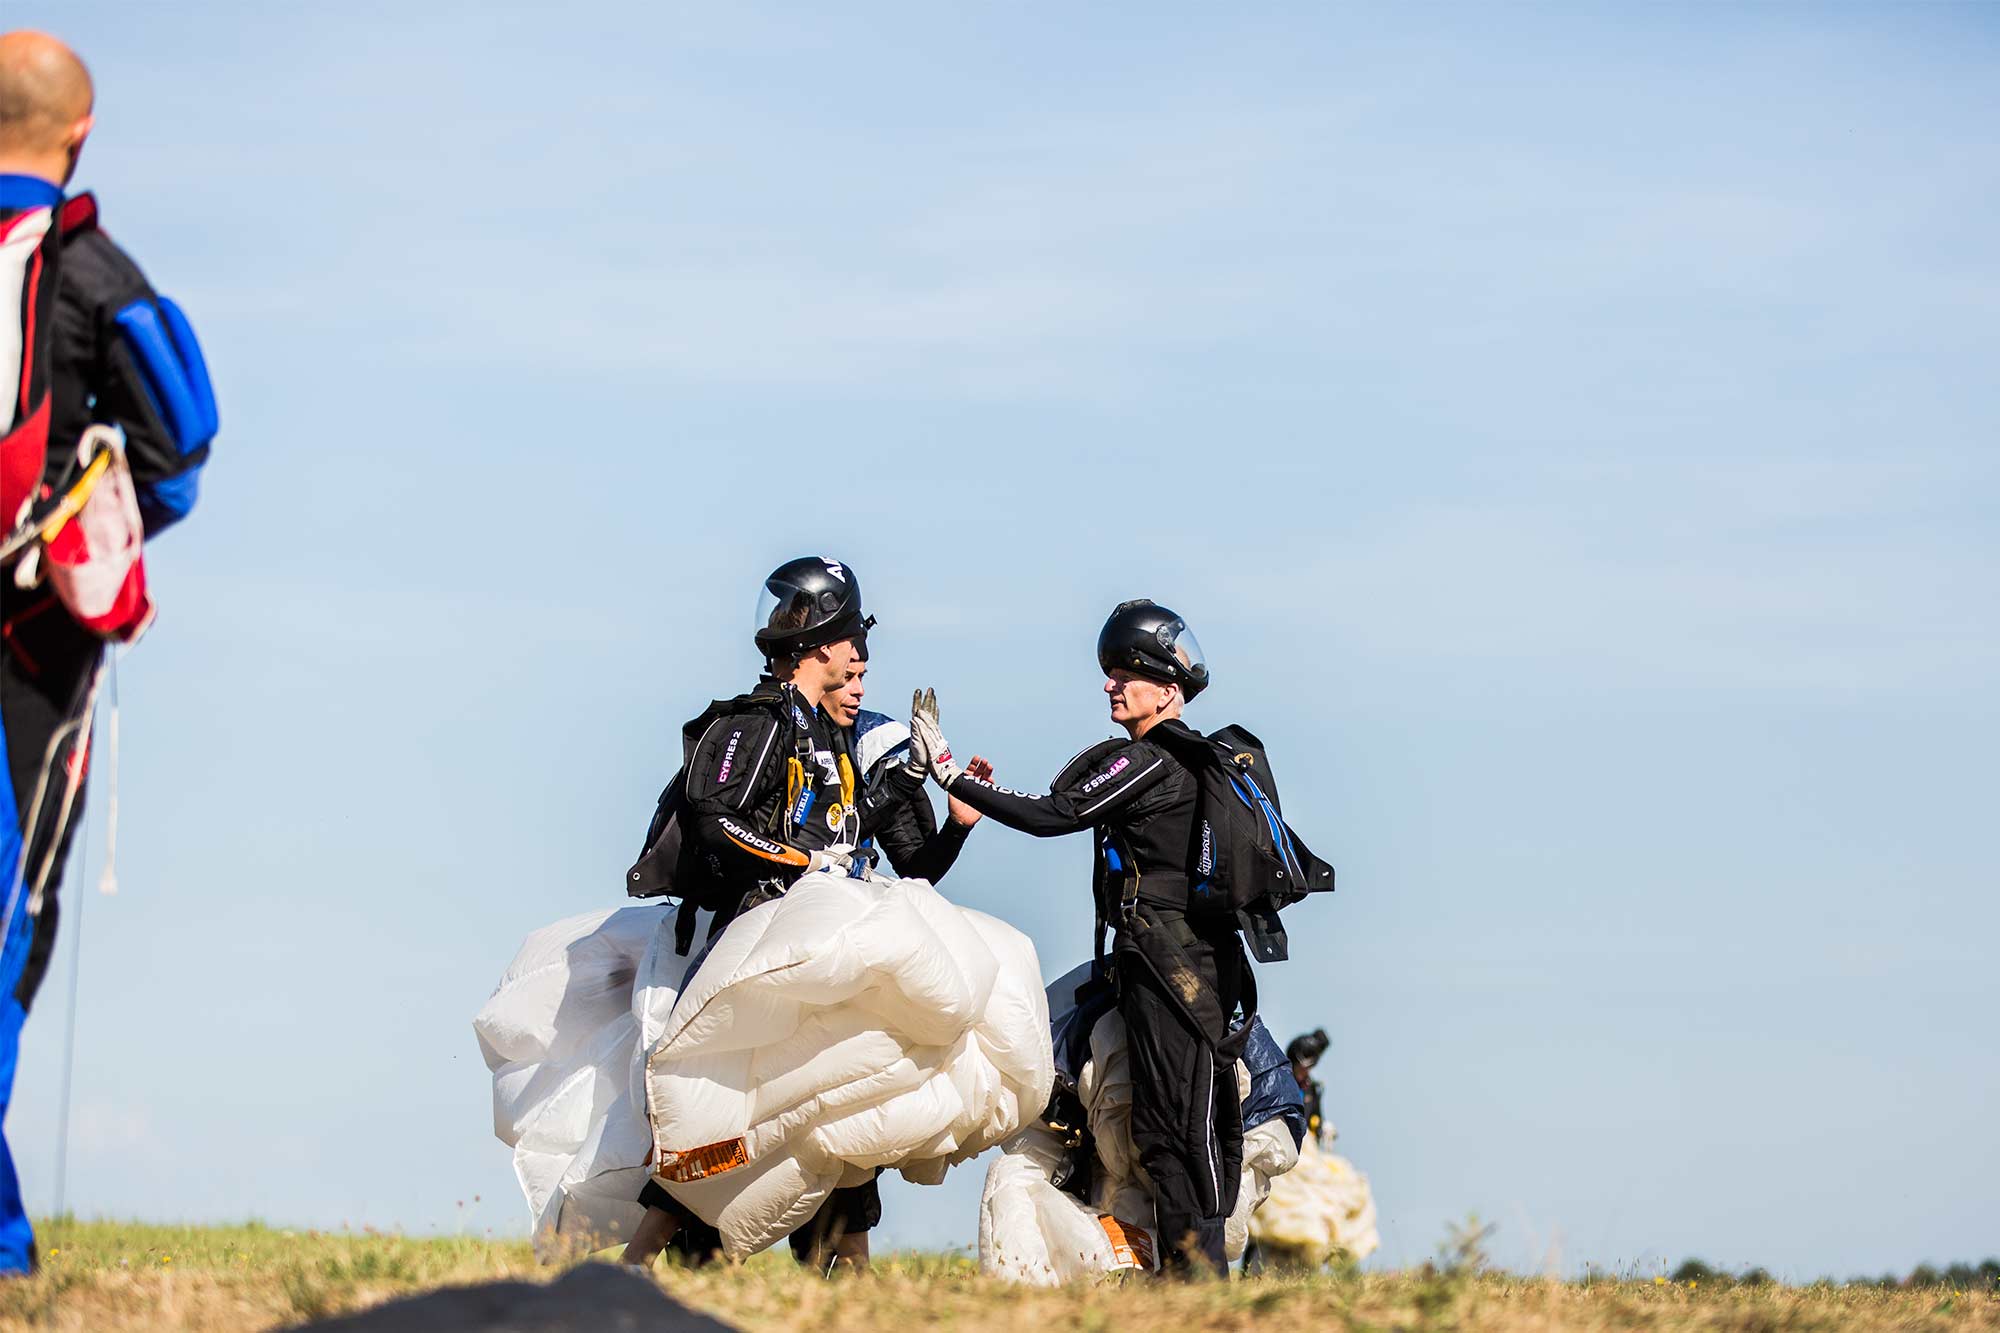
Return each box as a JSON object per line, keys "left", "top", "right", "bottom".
{"left": 980, "top": 965, "right": 1298, "bottom": 1287}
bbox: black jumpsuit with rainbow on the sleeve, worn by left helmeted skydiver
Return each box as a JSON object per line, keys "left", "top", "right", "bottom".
{"left": 640, "top": 679, "right": 924, "bottom": 1261}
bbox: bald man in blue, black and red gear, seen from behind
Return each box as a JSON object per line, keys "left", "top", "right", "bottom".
{"left": 0, "top": 32, "right": 216, "bottom": 1273}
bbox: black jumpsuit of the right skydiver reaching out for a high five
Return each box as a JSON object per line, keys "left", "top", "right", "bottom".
{"left": 950, "top": 721, "right": 1254, "bottom": 1273}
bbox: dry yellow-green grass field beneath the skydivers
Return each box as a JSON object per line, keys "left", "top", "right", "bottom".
{"left": 0, "top": 1221, "right": 2000, "bottom": 1333}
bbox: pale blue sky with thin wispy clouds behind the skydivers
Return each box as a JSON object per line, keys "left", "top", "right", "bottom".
{"left": 8, "top": 0, "right": 2000, "bottom": 1277}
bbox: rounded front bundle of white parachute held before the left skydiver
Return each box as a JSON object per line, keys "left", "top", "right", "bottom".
{"left": 646, "top": 873, "right": 1054, "bottom": 1257}
